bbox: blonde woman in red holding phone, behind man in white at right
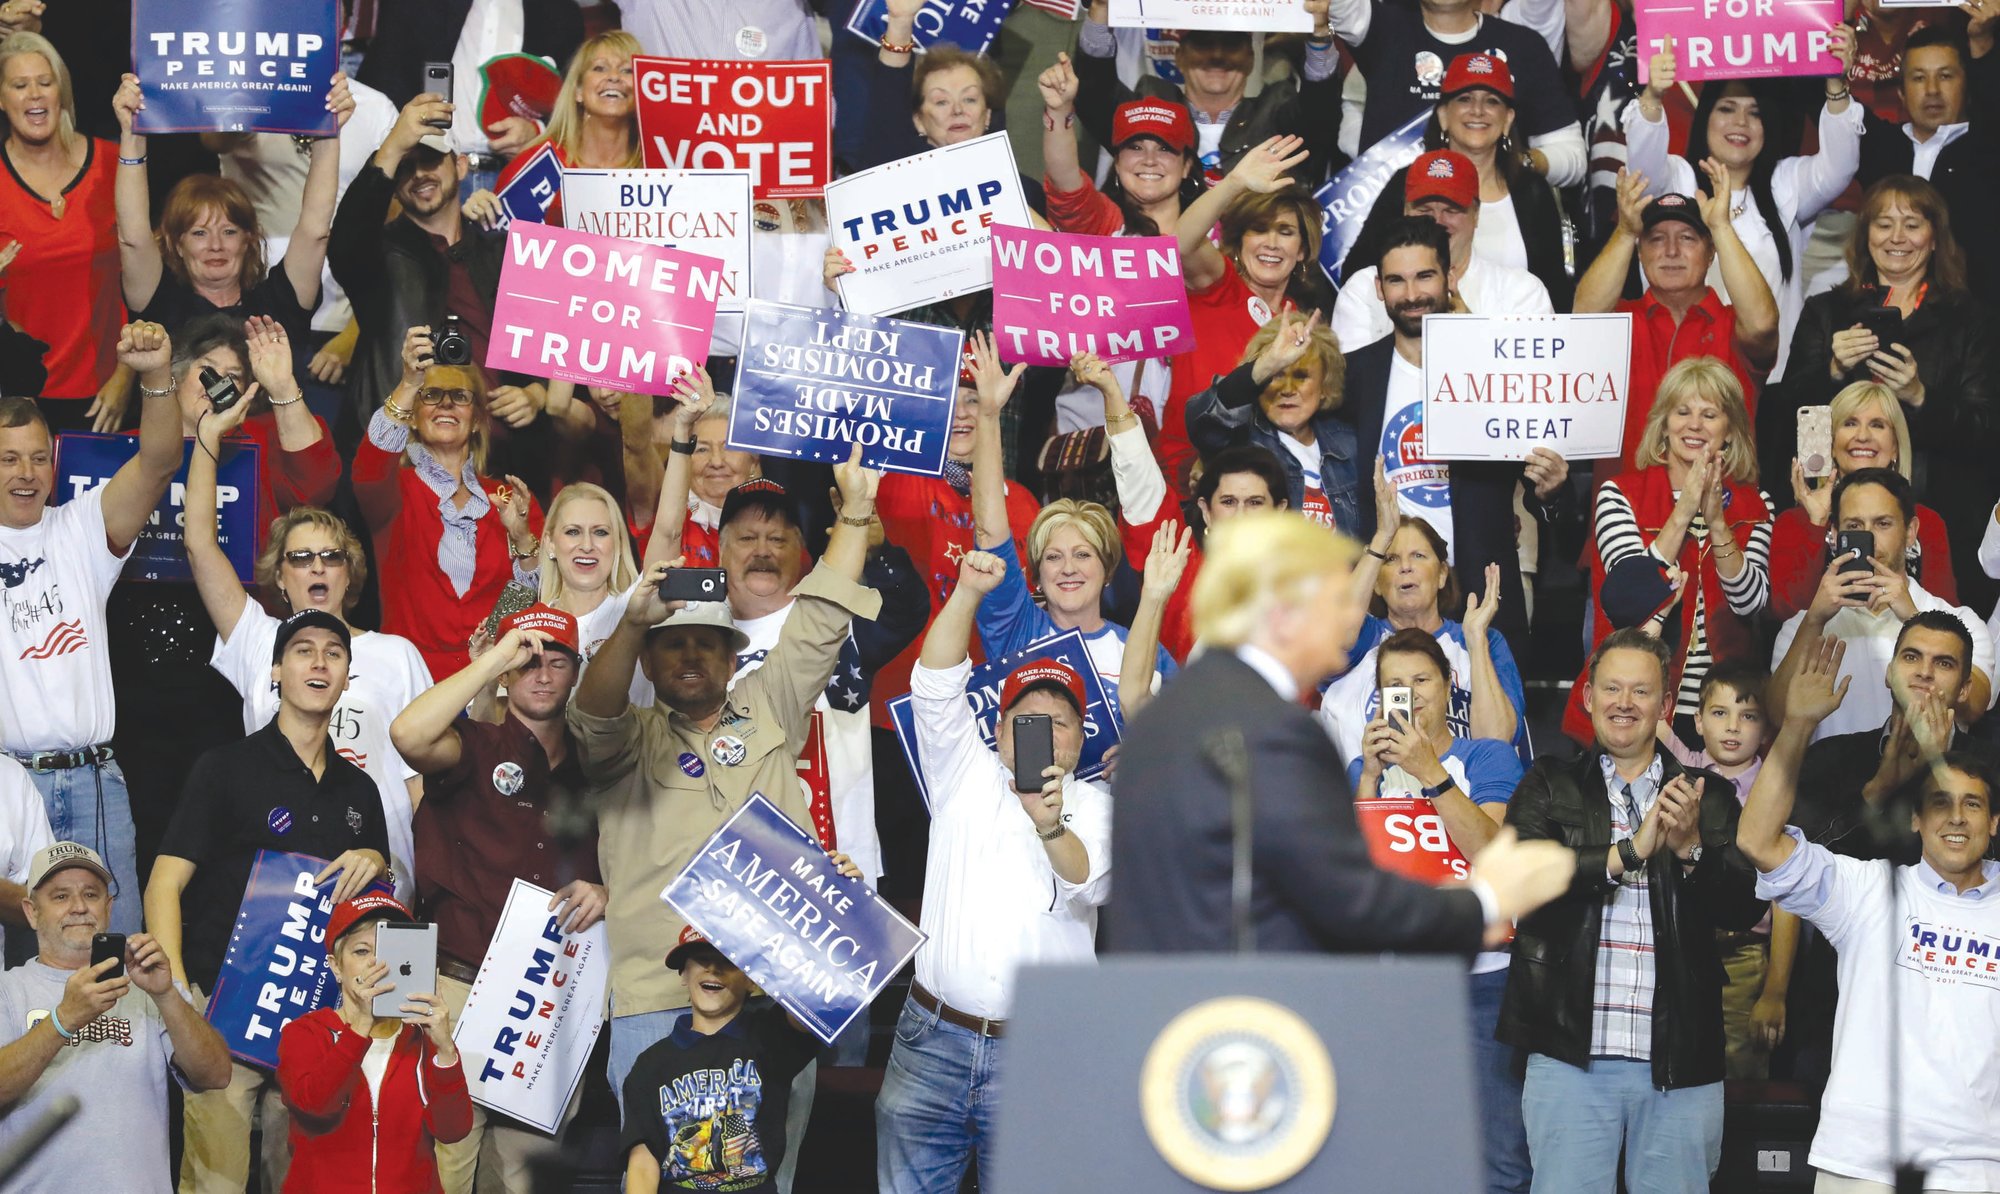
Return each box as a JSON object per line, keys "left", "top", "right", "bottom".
{"left": 1770, "top": 382, "right": 1958, "bottom": 620}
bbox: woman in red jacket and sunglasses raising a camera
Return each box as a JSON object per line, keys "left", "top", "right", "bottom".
{"left": 354, "top": 326, "right": 542, "bottom": 676}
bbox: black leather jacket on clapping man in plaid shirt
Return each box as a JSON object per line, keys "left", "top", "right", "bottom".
{"left": 1496, "top": 750, "right": 1764, "bottom": 1090}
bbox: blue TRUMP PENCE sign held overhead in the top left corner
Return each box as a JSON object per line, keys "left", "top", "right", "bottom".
{"left": 132, "top": 0, "right": 340, "bottom": 136}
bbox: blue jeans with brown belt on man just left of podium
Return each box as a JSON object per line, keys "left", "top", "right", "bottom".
{"left": 876, "top": 1002, "right": 1000, "bottom": 1194}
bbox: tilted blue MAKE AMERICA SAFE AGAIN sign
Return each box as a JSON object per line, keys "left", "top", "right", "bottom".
{"left": 660, "top": 792, "right": 926, "bottom": 1044}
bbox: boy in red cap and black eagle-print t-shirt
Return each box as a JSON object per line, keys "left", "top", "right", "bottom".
{"left": 624, "top": 854, "right": 860, "bottom": 1194}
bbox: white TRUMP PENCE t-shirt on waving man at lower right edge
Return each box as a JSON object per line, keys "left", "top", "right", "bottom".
{"left": 1756, "top": 832, "right": 2000, "bottom": 1190}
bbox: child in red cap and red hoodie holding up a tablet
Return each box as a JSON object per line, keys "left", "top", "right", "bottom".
{"left": 278, "top": 894, "right": 472, "bottom": 1194}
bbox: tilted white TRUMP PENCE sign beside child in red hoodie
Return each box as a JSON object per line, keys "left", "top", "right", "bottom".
{"left": 452, "top": 878, "right": 612, "bottom": 1134}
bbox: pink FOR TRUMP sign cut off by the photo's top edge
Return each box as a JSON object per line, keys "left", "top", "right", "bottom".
{"left": 1632, "top": 0, "right": 1842, "bottom": 84}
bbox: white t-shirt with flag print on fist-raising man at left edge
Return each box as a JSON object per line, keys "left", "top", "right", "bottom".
{"left": 0, "top": 478, "right": 132, "bottom": 752}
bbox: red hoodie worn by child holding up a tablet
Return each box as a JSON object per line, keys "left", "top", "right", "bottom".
{"left": 278, "top": 1008, "right": 472, "bottom": 1194}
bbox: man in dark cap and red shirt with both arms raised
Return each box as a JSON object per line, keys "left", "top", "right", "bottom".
{"left": 1576, "top": 170, "right": 1778, "bottom": 482}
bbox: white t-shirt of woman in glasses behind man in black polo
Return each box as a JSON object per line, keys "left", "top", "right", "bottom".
{"left": 208, "top": 602, "right": 432, "bottom": 902}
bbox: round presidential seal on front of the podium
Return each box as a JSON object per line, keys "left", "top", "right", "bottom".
{"left": 1140, "top": 996, "right": 1334, "bottom": 1190}
